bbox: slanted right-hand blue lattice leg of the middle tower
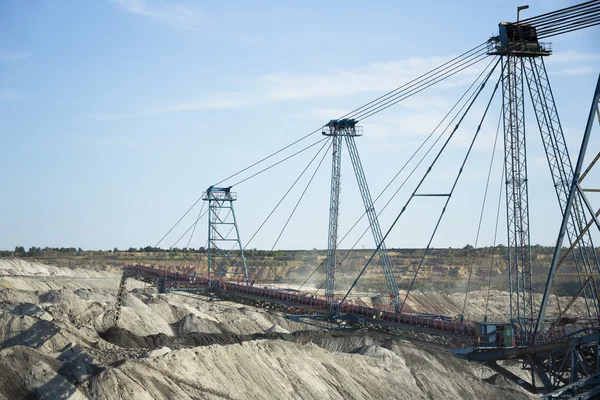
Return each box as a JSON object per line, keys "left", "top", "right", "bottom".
{"left": 345, "top": 136, "right": 400, "bottom": 312}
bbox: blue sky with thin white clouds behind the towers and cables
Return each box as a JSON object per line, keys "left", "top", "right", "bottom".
{"left": 0, "top": 0, "right": 600, "bottom": 249}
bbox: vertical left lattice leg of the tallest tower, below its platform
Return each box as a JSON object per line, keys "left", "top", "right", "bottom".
{"left": 502, "top": 54, "right": 534, "bottom": 337}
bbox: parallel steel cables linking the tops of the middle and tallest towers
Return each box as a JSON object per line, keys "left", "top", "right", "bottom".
{"left": 344, "top": 42, "right": 486, "bottom": 118}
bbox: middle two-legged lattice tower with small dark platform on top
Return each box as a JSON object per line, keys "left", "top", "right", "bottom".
{"left": 323, "top": 119, "right": 400, "bottom": 312}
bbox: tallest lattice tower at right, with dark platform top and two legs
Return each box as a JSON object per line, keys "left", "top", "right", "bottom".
{"left": 488, "top": 22, "right": 600, "bottom": 341}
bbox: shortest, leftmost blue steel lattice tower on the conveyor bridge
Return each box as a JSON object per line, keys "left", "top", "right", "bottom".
{"left": 202, "top": 186, "right": 250, "bottom": 285}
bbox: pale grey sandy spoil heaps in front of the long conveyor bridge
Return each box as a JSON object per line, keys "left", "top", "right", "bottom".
{"left": 0, "top": 260, "right": 532, "bottom": 400}
